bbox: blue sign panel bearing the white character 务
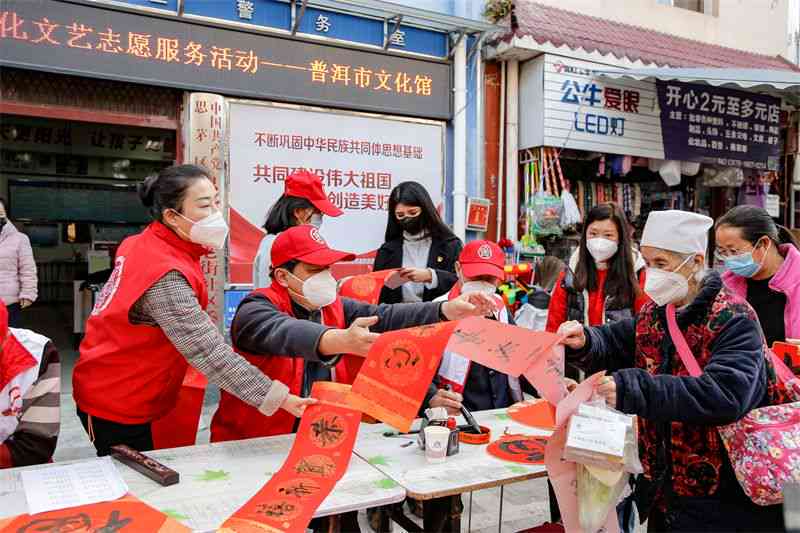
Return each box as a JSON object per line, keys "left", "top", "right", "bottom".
{"left": 298, "top": 7, "right": 383, "bottom": 46}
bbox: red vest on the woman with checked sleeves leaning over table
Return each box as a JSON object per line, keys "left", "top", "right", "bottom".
{"left": 72, "top": 222, "right": 208, "bottom": 424}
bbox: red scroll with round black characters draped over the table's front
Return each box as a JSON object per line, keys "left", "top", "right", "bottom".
{"left": 219, "top": 382, "right": 361, "bottom": 533}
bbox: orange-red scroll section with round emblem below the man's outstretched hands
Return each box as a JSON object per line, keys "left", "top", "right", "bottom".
{"left": 350, "top": 322, "right": 458, "bottom": 432}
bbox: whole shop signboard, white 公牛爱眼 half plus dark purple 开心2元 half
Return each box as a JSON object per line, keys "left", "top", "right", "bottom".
{"left": 520, "top": 54, "right": 780, "bottom": 169}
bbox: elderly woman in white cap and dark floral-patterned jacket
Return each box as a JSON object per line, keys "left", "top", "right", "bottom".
{"left": 559, "top": 211, "right": 783, "bottom": 531}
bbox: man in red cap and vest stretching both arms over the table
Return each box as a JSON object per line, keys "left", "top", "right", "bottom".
{"left": 211, "top": 225, "right": 496, "bottom": 442}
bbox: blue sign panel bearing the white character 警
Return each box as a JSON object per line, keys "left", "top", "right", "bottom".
{"left": 183, "top": 0, "right": 292, "bottom": 31}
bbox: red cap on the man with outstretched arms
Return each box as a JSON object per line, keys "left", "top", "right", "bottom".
{"left": 271, "top": 225, "right": 356, "bottom": 267}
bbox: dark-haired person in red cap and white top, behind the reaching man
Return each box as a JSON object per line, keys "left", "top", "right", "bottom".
{"left": 253, "top": 170, "right": 342, "bottom": 289}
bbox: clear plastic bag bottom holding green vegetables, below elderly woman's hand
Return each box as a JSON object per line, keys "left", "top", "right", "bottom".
{"left": 577, "top": 464, "right": 630, "bottom": 531}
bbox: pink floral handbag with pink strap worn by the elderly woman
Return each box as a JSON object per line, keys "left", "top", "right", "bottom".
{"left": 667, "top": 304, "right": 800, "bottom": 505}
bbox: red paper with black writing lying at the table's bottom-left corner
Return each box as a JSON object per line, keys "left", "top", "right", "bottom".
{"left": 0, "top": 494, "right": 191, "bottom": 533}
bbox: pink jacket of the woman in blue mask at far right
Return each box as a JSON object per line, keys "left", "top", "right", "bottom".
{"left": 722, "top": 244, "right": 800, "bottom": 339}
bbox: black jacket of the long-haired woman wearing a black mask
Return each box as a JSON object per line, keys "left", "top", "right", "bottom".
{"left": 373, "top": 236, "right": 464, "bottom": 304}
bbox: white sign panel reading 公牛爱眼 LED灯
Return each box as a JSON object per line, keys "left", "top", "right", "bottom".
{"left": 520, "top": 54, "right": 664, "bottom": 158}
